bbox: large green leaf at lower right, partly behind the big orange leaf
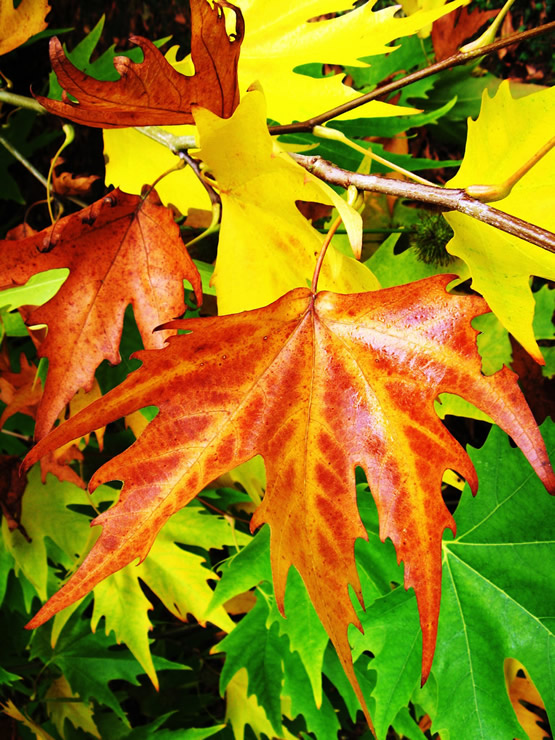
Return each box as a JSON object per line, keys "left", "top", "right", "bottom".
{"left": 336, "top": 422, "right": 555, "bottom": 740}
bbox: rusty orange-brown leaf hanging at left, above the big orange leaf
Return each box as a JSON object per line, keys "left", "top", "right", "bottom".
{"left": 0, "top": 190, "right": 202, "bottom": 439}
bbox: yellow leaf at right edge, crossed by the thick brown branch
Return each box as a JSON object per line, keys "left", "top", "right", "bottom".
{"left": 445, "top": 81, "right": 555, "bottom": 364}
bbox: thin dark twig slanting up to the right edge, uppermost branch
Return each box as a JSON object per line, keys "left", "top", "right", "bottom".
{"left": 268, "top": 21, "right": 555, "bottom": 135}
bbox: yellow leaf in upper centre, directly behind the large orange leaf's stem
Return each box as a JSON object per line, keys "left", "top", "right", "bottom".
{"left": 195, "top": 90, "right": 379, "bottom": 314}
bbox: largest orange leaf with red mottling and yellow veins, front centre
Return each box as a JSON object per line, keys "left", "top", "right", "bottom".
{"left": 26, "top": 275, "right": 555, "bottom": 724}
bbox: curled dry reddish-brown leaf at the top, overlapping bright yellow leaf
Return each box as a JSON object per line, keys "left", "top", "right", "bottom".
{"left": 36, "top": 0, "right": 244, "bottom": 128}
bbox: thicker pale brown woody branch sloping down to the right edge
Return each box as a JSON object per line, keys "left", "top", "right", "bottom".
{"left": 298, "top": 153, "right": 555, "bottom": 253}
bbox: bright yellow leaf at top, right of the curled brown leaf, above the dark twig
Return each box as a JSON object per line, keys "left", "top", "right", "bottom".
{"left": 175, "top": 0, "right": 468, "bottom": 123}
